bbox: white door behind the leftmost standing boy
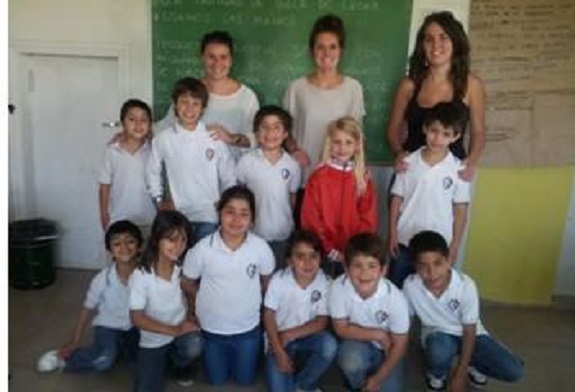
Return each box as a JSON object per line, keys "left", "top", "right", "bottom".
{"left": 23, "top": 55, "right": 121, "bottom": 268}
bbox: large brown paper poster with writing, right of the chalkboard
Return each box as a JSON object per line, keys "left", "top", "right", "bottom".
{"left": 469, "top": 0, "right": 575, "bottom": 166}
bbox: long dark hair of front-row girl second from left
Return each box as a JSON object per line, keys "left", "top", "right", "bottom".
{"left": 140, "top": 211, "right": 193, "bottom": 272}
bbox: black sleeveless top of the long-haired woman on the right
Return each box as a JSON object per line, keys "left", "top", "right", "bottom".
{"left": 403, "top": 86, "right": 469, "bottom": 160}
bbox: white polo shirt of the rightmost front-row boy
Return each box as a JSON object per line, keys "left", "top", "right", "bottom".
{"left": 403, "top": 268, "right": 487, "bottom": 344}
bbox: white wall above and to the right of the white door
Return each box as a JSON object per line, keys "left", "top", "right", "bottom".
{"left": 8, "top": 0, "right": 152, "bottom": 103}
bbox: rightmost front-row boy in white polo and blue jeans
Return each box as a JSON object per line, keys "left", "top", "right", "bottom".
{"left": 403, "top": 231, "right": 523, "bottom": 392}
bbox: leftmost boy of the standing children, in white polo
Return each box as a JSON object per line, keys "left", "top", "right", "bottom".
{"left": 98, "top": 99, "right": 156, "bottom": 237}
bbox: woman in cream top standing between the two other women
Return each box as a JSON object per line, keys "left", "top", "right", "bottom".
{"left": 283, "top": 15, "right": 365, "bottom": 221}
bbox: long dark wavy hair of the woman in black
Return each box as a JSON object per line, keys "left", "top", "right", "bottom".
{"left": 408, "top": 11, "right": 470, "bottom": 97}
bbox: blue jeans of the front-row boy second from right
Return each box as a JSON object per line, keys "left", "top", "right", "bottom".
{"left": 337, "top": 339, "right": 405, "bottom": 392}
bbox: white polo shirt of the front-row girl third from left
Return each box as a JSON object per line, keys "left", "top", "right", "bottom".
{"left": 183, "top": 231, "right": 275, "bottom": 335}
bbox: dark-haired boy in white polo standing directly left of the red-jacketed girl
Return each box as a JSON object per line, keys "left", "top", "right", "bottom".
{"left": 236, "top": 105, "right": 301, "bottom": 269}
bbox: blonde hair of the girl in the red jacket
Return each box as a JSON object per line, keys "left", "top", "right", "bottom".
{"left": 321, "top": 116, "right": 367, "bottom": 194}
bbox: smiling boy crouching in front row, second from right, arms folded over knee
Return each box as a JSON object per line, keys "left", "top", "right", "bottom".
{"left": 328, "top": 233, "right": 409, "bottom": 392}
